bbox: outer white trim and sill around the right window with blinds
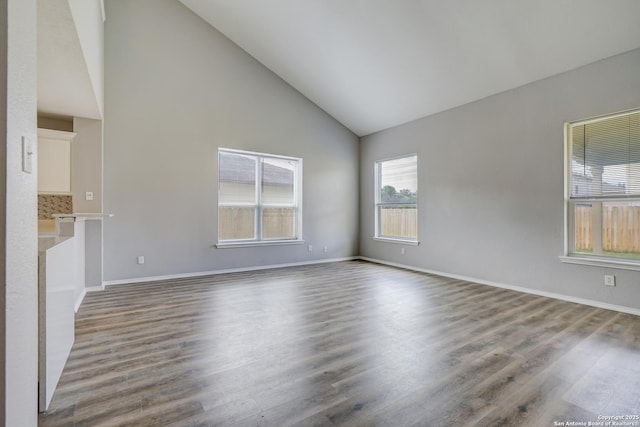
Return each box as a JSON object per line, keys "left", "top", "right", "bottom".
{"left": 558, "top": 109, "right": 640, "bottom": 271}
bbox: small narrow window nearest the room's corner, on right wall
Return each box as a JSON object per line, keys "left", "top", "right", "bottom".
{"left": 375, "top": 154, "right": 418, "bottom": 244}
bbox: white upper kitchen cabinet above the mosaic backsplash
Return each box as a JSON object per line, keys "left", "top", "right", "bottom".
{"left": 38, "top": 129, "right": 76, "bottom": 194}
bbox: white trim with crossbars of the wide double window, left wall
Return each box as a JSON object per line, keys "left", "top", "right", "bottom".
{"left": 215, "top": 148, "right": 304, "bottom": 249}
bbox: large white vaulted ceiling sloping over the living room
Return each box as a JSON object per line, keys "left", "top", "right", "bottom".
{"left": 180, "top": 0, "right": 640, "bottom": 136}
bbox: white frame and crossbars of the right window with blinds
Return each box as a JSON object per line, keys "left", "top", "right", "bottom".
{"left": 560, "top": 109, "right": 640, "bottom": 271}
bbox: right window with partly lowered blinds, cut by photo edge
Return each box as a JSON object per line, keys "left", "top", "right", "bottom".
{"left": 567, "top": 111, "right": 640, "bottom": 266}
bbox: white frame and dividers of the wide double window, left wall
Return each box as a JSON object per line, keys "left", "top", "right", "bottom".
{"left": 215, "top": 147, "right": 304, "bottom": 248}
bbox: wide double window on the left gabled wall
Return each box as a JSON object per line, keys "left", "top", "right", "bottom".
{"left": 218, "top": 149, "right": 302, "bottom": 246}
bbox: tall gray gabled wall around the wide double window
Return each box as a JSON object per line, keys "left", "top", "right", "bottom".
{"left": 104, "top": 0, "right": 359, "bottom": 282}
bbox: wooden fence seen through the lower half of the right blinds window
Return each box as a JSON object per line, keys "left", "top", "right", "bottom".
{"left": 575, "top": 205, "right": 640, "bottom": 252}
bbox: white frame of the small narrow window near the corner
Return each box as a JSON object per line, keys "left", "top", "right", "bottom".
{"left": 373, "top": 153, "right": 420, "bottom": 245}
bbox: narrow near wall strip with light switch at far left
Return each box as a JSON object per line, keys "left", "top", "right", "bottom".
{"left": 0, "top": 0, "right": 38, "bottom": 426}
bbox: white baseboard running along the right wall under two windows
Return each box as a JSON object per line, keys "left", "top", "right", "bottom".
{"left": 358, "top": 256, "right": 640, "bottom": 316}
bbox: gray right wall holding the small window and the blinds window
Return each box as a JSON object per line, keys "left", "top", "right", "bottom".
{"left": 360, "top": 50, "right": 640, "bottom": 309}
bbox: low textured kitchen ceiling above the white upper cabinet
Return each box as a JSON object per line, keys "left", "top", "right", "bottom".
{"left": 38, "top": 0, "right": 102, "bottom": 119}
